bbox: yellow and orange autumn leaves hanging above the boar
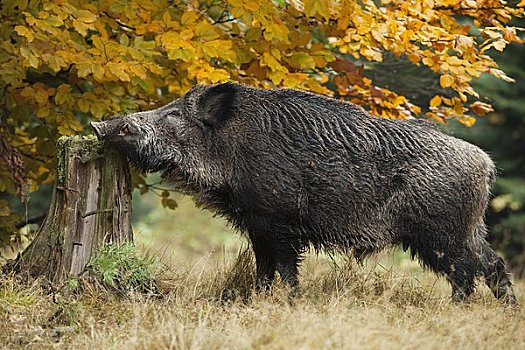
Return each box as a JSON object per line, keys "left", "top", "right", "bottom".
{"left": 0, "top": 0, "right": 525, "bottom": 245}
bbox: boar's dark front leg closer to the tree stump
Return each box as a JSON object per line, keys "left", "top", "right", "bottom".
{"left": 250, "top": 235, "right": 276, "bottom": 291}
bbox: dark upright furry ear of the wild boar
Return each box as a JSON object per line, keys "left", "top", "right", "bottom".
{"left": 198, "top": 83, "right": 237, "bottom": 127}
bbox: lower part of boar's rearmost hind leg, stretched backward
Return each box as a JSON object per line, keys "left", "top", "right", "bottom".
{"left": 481, "top": 239, "right": 517, "bottom": 306}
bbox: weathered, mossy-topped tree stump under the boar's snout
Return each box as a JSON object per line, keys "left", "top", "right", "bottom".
{"left": 8, "top": 136, "right": 133, "bottom": 283}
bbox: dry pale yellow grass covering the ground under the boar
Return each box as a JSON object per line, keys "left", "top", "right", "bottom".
{"left": 0, "top": 247, "right": 525, "bottom": 350}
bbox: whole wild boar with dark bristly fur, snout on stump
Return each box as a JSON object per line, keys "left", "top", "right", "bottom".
{"left": 90, "top": 83, "right": 516, "bottom": 304}
